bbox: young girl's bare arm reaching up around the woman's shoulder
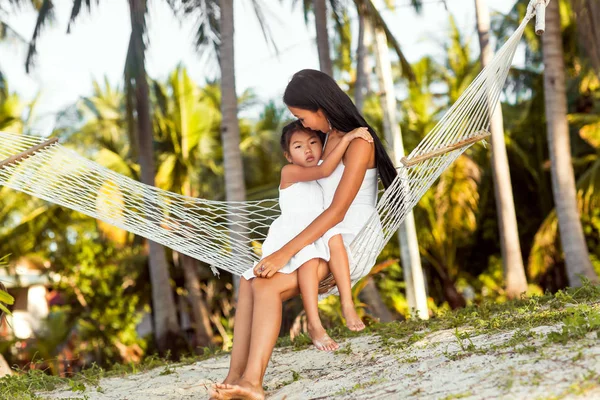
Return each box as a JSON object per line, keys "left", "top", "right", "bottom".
{"left": 281, "top": 128, "right": 373, "bottom": 184}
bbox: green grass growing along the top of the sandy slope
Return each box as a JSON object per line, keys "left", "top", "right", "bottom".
{"left": 0, "top": 281, "right": 600, "bottom": 400}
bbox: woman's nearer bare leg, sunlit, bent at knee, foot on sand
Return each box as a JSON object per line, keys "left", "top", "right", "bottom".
{"left": 215, "top": 263, "right": 329, "bottom": 400}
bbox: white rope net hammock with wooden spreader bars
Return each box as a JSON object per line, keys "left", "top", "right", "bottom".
{"left": 0, "top": 0, "right": 548, "bottom": 284}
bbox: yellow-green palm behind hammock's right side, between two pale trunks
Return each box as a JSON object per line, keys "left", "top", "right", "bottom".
{"left": 403, "top": 17, "right": 481, "bottom": 308}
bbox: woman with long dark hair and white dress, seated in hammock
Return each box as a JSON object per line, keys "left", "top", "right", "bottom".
{"left": 211, "top": 70, "right": 396, "bottom": 399}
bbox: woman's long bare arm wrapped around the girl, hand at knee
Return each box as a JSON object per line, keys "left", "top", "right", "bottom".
{"left": 254, "top": 140, "right": 373, "bottom": 278}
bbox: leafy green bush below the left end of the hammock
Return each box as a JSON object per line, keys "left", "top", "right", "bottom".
{"left": 44, "top": 230, "right": 145, "bottom": 364}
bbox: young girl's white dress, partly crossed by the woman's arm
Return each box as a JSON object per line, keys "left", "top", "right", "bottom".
{"left": 242, "top": 181, "right": 329, "bottom": 280}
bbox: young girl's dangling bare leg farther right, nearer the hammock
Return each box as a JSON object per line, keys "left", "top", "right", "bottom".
{"left": 329, "top": 235, "right": 365, "bottom": 331}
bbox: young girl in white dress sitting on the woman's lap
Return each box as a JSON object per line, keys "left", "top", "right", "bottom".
{"left": 243, "top": 121, "right": 373, "bottom": 351}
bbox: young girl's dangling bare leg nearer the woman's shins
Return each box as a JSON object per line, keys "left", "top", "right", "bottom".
{"left": 298, "top": 258, "right": 340, "bottom": 351}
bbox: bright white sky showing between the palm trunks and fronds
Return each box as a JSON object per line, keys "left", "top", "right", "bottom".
{"left": 0, "top": 0, "right": 526, "bottom": 134}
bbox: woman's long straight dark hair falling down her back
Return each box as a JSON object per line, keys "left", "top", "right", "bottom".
{"left": 283, "top": 69, "right": 397, "bottom": 189}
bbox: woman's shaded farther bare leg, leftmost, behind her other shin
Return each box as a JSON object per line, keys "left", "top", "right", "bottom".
{"left": 223, "top": 278, "right": 254, "bottom": 383}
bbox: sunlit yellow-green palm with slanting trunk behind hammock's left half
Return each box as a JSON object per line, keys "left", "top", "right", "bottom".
{"left": 154, "top": 67, "right": 219, "bottom": 347}
